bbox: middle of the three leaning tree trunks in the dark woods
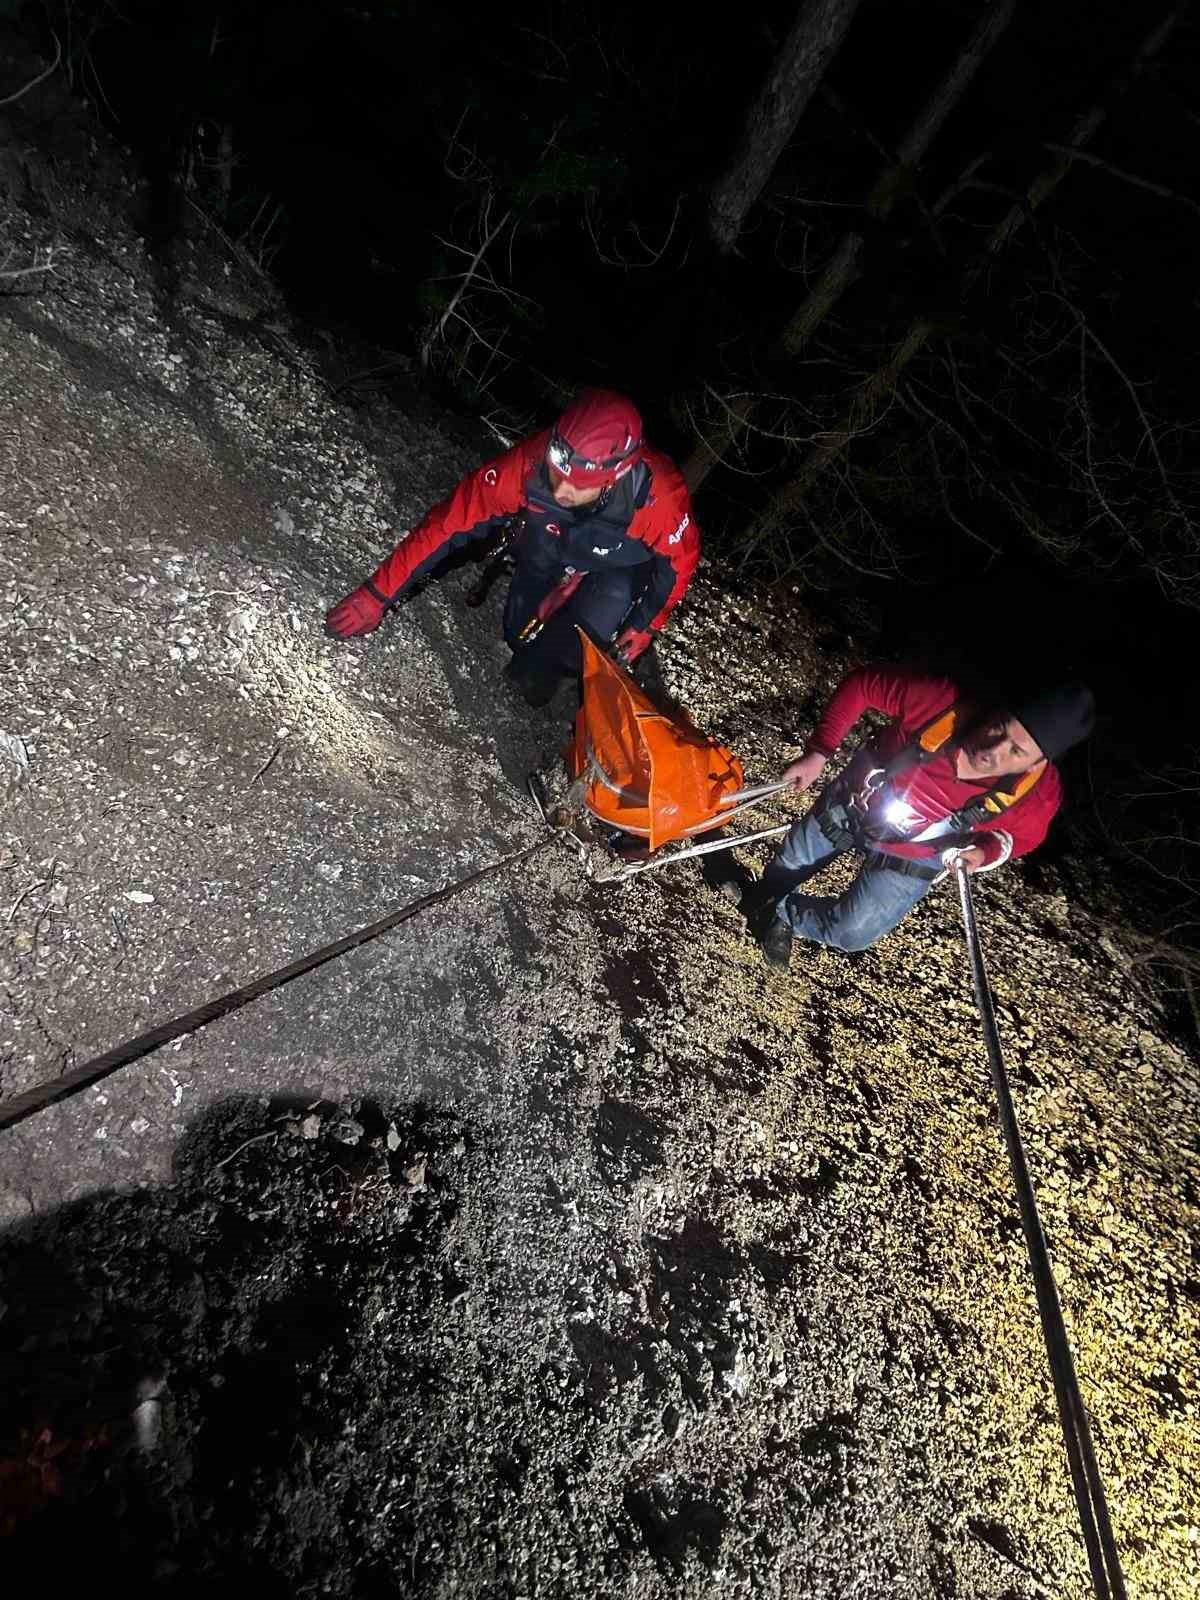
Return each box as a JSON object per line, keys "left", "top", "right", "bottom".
{"left": 683, "top": 0, "right": 1016, "bottom": 491}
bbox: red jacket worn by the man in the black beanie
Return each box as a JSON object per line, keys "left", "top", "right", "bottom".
{"left": 806, "top": 666, "right": 1062, "bottom": 867}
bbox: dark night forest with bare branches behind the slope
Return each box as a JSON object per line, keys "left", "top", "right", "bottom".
{"left": 0, "top": 0, "right": 1200, "bottom": 972}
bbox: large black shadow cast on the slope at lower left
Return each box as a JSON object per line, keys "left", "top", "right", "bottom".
{"left": 0, "top": 1099, "right": 467, "bottom": 1600}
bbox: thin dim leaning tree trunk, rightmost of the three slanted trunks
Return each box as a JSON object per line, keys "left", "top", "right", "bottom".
{"left": 750, "top": 0, "right": 1187, "bottom": 546}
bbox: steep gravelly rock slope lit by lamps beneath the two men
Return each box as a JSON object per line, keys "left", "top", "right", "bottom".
{"left": 0, "top": 28, "right": 1200, "bottom": 1600}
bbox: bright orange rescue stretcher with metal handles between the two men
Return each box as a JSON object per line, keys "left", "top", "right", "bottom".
{"left": 530, "top": 632, "right": 790, "bottom": 882}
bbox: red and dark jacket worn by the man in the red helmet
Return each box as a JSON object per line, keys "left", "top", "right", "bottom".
{"left": 371, "top": 429, "right": 699, "bottom": 629}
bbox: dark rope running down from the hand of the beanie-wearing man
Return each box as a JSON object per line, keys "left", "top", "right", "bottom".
{"left": 954, "top": 858, "right": 1126, "bottom": 1600}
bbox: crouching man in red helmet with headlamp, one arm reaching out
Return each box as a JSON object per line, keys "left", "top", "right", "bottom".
{"left": 325, "top": 389, "right": 699, "bottom": 706}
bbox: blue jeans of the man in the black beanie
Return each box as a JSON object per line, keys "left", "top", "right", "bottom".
{"left": 771, "top": 811, "right": 933, "bottom": 950}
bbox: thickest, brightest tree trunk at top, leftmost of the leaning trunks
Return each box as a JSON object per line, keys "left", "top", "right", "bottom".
{"left": 707, "top": 0, "right": 859, "bottom": 256}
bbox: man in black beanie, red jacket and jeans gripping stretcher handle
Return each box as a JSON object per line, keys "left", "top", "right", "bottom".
{"left": 744, "top": 666, "right": 1094, "bottom": 966}
